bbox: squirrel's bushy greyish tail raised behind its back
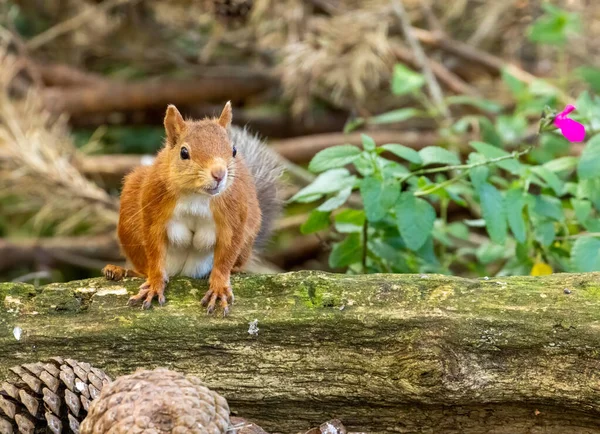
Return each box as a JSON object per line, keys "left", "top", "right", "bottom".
{"left": 229, "top": 126, "right": 283, "bottom": 250}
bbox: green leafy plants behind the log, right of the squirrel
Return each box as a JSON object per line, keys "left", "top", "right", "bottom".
{"left": 294, "top": 5, "right": 600, "bottom": 275}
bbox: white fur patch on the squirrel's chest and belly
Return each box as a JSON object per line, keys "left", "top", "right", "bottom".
{"left": 165, "top": 194, "right": 217, "bottom": 278}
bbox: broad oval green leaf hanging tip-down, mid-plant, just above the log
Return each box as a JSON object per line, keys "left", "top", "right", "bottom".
{"left": 396, "top": 192, "right": 435, "bottom": 251}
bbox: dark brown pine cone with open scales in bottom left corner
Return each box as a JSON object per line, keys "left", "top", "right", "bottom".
{"left": 0, "top": 357, "right": 111, "bottom": 434}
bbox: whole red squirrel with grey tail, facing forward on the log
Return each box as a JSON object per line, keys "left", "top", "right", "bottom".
{"left": 102, "top": 102, "right": 282, "bottom": 315}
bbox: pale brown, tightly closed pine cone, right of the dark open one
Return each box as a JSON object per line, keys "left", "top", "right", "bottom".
{"left": 81, "top": 368, "right": 230, "bottom": 434}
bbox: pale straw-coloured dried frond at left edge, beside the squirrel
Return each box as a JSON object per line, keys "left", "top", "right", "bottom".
{"left": 0, "top": 47, "right": 118, "bottom": 235}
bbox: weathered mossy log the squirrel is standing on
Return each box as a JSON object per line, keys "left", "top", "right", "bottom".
{"left": 0, "top": 272, "right": 600, "bottom": 433}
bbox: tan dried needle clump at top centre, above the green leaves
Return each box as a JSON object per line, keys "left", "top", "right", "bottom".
{"left": 279, "top": 9, "right": 394, "bottom": 114}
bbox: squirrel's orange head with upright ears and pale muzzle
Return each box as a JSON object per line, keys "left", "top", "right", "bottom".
{"left": 164, "top": 102, "right": 237, "bottom": 196}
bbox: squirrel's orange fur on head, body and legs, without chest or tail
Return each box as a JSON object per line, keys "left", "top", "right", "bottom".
{"left": 107, "top": 103, "right": 261, "bottom": 314}
